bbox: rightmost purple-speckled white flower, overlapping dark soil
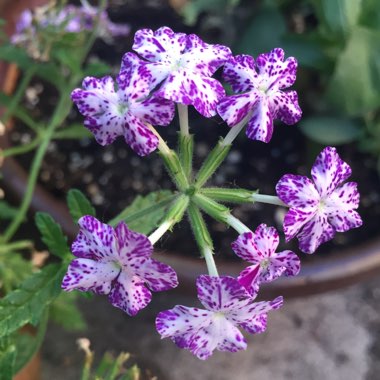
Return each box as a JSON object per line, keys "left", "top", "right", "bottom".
{"left": 276, "top": 147, "right": 363, "bottom": 253}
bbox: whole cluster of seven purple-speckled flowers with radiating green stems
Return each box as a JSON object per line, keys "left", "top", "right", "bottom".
{"left": 62, "top": 27, "right": 362, "bottom": 359}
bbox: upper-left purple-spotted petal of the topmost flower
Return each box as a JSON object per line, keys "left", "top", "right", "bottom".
{"left": 132, "top": 26, "right": 187, "bottom": 64}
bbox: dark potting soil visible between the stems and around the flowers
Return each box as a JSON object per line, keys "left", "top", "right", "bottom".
{"left": 5, "top": 1, "right": 380, "bottom": 259}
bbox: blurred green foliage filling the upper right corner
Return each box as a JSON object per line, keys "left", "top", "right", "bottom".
{"left": 173, "top": 0, "right": 380, "bottom": 170}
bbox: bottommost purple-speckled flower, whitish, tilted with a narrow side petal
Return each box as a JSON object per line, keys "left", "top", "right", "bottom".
{"left": 156, "top": 275, "right": 283, "bottom": 360}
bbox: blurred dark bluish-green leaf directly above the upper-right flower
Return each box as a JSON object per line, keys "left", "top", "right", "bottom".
{"left": 236, "top": 7, "right": 286, "bottom": 56}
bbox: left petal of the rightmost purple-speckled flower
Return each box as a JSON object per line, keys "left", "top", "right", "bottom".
{"left": 276, "top": 174, "right": 320, "bottom": 208}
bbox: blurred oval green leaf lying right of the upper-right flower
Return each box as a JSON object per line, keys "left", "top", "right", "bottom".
{"left": 299, "top": 116, "right": 362, "bottom": 145}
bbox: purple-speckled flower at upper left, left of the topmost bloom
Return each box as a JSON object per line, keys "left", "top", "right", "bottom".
{"left": 71, "top": 53, "right": 174, "bottom": 156}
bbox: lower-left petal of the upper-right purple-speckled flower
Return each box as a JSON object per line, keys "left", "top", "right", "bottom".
{"left": 217, "top": 91, "right": 259, "bottom": 127}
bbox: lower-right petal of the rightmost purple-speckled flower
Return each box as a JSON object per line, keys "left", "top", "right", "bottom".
{"left": 324, "top": 182, "right": 363, "bottom": 232}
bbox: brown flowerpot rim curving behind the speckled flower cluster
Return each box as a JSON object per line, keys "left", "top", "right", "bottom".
{"left": 0, "top": 0, "right": 380, "bottom": 297}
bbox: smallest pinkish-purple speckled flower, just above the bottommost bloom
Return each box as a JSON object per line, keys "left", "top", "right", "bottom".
{"left": 232, "top": 224, "right": 300, "bottom": 294}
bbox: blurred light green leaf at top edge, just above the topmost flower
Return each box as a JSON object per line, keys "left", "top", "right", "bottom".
{"left": 180, "top": 0, "right": 240, "bottom": 25}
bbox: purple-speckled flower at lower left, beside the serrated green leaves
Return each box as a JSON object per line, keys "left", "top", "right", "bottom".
{"left": 62, "top": 216, "right": 178, "bottom": 315}
